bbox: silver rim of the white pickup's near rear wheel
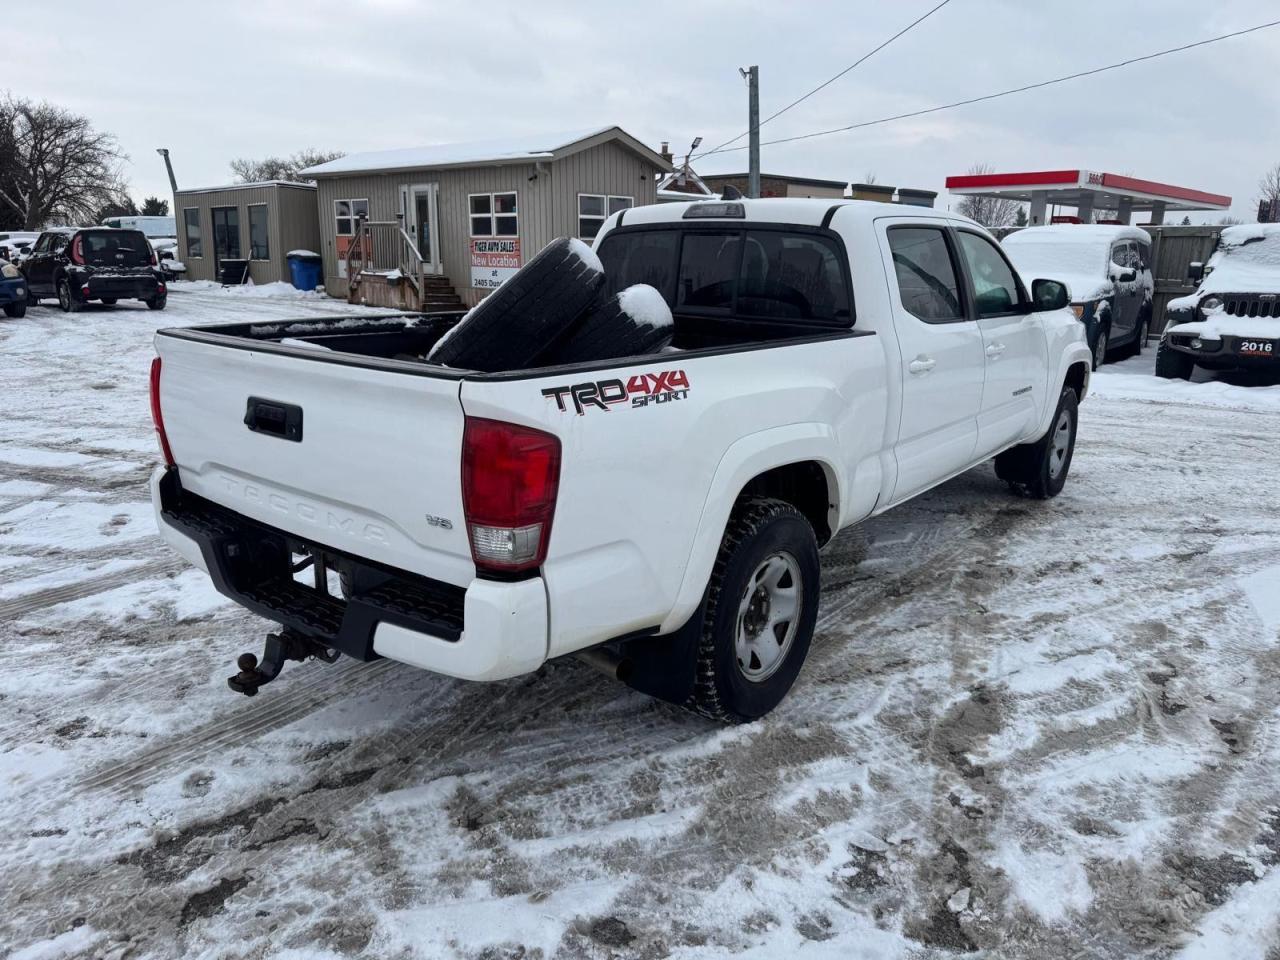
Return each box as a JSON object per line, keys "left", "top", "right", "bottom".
{"left": 733, "top": 553, "right": 801, "bottom": 684}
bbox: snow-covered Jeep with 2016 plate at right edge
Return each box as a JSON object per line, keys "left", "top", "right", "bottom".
{"left": 1156, "top": 223, "right": 1280, "bottom": 380}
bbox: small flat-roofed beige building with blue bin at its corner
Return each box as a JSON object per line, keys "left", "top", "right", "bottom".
{"left": 173, "top": 180, "right": 320, "bottom": 283}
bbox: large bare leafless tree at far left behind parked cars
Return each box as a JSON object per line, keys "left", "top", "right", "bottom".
{"left": 0, "top": 93, "right": 125, "bottom": 229}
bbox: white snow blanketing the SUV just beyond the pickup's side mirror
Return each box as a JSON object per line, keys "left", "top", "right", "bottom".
{"left": 1001, "top": 224, "right": 1151, "bottom": 303}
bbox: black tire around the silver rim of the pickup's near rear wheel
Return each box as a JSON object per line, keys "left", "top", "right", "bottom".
{"left": 686, "top": 499, "right": 820, "bottom": 723}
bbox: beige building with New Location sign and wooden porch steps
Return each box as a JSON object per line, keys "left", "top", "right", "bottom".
{"left": 303, "top": 127, "right": 671, "bottom": 308}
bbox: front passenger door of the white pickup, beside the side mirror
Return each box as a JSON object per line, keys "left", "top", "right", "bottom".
{"left": 956, "top": 228, "right": 1048, "bottom": 460}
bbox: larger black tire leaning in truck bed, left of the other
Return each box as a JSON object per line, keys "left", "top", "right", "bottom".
{"left": 428, "top": 237, "right": 604, "bottom": 372}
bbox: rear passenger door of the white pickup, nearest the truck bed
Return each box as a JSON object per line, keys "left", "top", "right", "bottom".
{"left": 878, "top": 218, "right": 984, "bottom": 500}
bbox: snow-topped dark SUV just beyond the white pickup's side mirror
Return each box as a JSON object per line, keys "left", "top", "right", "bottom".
{"left": 1004, "top": 224, "right": 1156, "bottom": 370}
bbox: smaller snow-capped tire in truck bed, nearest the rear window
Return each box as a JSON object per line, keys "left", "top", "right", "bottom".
{"left": 541, "top": 283, "right": 675, "bottom": 366}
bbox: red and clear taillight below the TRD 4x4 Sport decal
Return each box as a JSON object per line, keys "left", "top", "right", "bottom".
{"left": 462, "top": 417, "right": 561, "bottom": 573}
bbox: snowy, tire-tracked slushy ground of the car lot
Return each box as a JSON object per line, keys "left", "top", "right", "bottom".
{"left": 0, "top": 296, "right": 1280, "bottom": 960}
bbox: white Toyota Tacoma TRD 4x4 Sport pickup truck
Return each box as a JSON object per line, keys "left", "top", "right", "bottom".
{"left": 151, "top": 200, "right": 1091, "bottom": 722}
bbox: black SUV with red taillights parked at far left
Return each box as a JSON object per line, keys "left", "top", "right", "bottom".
{"left": 22, "top": 227, "right": 169, "bottom": 314}
